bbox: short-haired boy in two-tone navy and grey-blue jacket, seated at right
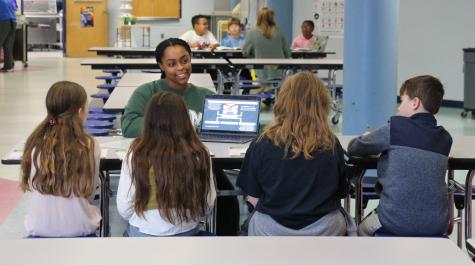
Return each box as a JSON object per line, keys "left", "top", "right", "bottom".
{"left": 348, "top": 75, "right": 452, "bottom": 236}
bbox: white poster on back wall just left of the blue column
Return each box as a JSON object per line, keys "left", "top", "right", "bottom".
{"left": 314, "top": 0, "right": 345, "bottom": 35}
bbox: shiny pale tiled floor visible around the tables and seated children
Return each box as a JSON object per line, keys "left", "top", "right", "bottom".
{"left": 0, "top": 53, "right": 475, "bottom": 246}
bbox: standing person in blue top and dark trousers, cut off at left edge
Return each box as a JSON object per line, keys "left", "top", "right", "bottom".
{"left": 0, "top": 0, "right": 17, "bottom": 72}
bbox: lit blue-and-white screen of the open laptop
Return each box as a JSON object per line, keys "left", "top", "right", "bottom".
{"left": 201, "top": 95, "right": 261, "bottom": 133}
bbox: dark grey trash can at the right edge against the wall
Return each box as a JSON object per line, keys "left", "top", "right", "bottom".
{"left": 461, "top": 48, "right": 475, "bottom": 118}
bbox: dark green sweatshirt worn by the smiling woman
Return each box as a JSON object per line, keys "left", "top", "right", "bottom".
{"left": 122, "top": 79, "right": 213, "bottom": 138}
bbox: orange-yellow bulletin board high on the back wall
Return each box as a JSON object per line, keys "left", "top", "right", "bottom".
{"left": 132, "top": 0, "right": 181, "bottom": 20}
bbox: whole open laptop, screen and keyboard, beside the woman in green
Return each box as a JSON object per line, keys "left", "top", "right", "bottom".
{"left": 200, "top": 95, "right": 261, "bottom": 143}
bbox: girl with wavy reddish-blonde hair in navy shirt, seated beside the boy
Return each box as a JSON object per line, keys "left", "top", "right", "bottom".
{"left": 237, "top": 72, "right": 354, "bottom": 236}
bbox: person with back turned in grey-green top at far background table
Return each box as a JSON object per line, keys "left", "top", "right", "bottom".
{"left": 242, "top": 7, "right": 291, "bottom": 89}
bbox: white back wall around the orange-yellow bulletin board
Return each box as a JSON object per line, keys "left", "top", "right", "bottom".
{"left": 109, "top": 0, "right": 215, "bottom": 47}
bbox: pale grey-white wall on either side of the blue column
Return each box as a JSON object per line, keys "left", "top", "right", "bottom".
{"left": 293, "top": 0, "right": 475, "bottom": 101}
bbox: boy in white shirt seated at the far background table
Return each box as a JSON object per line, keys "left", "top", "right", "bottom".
{"left": 180, "top": 15, "right": 219, "bottom": 49}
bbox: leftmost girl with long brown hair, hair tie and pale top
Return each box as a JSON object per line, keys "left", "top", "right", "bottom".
{"left": 21, "top": 81, "right": 101, "bottom": 237}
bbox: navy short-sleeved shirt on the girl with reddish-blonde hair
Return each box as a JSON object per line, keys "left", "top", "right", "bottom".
{"left": 237, "top": 138, "right": 346, "bottom": 229}
